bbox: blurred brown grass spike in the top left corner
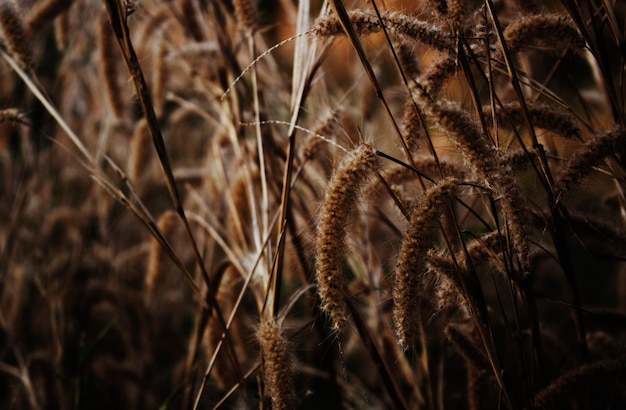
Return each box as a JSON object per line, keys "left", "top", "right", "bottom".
{"left": 0, "top": 1, "right": 33, "bottom": 69}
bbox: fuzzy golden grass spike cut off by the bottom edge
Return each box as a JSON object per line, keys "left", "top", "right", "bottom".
{"left": 257, "top": 318, "right": 296, "bottom": 410}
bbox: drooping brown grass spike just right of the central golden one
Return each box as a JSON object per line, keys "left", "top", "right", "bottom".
{"left": 393, "top": 178, "right": 458, "bottom": 349}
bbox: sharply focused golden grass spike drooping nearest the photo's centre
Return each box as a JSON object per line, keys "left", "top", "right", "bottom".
{"left": 315, "top": 144, "right": 377, "bottom": 330}
